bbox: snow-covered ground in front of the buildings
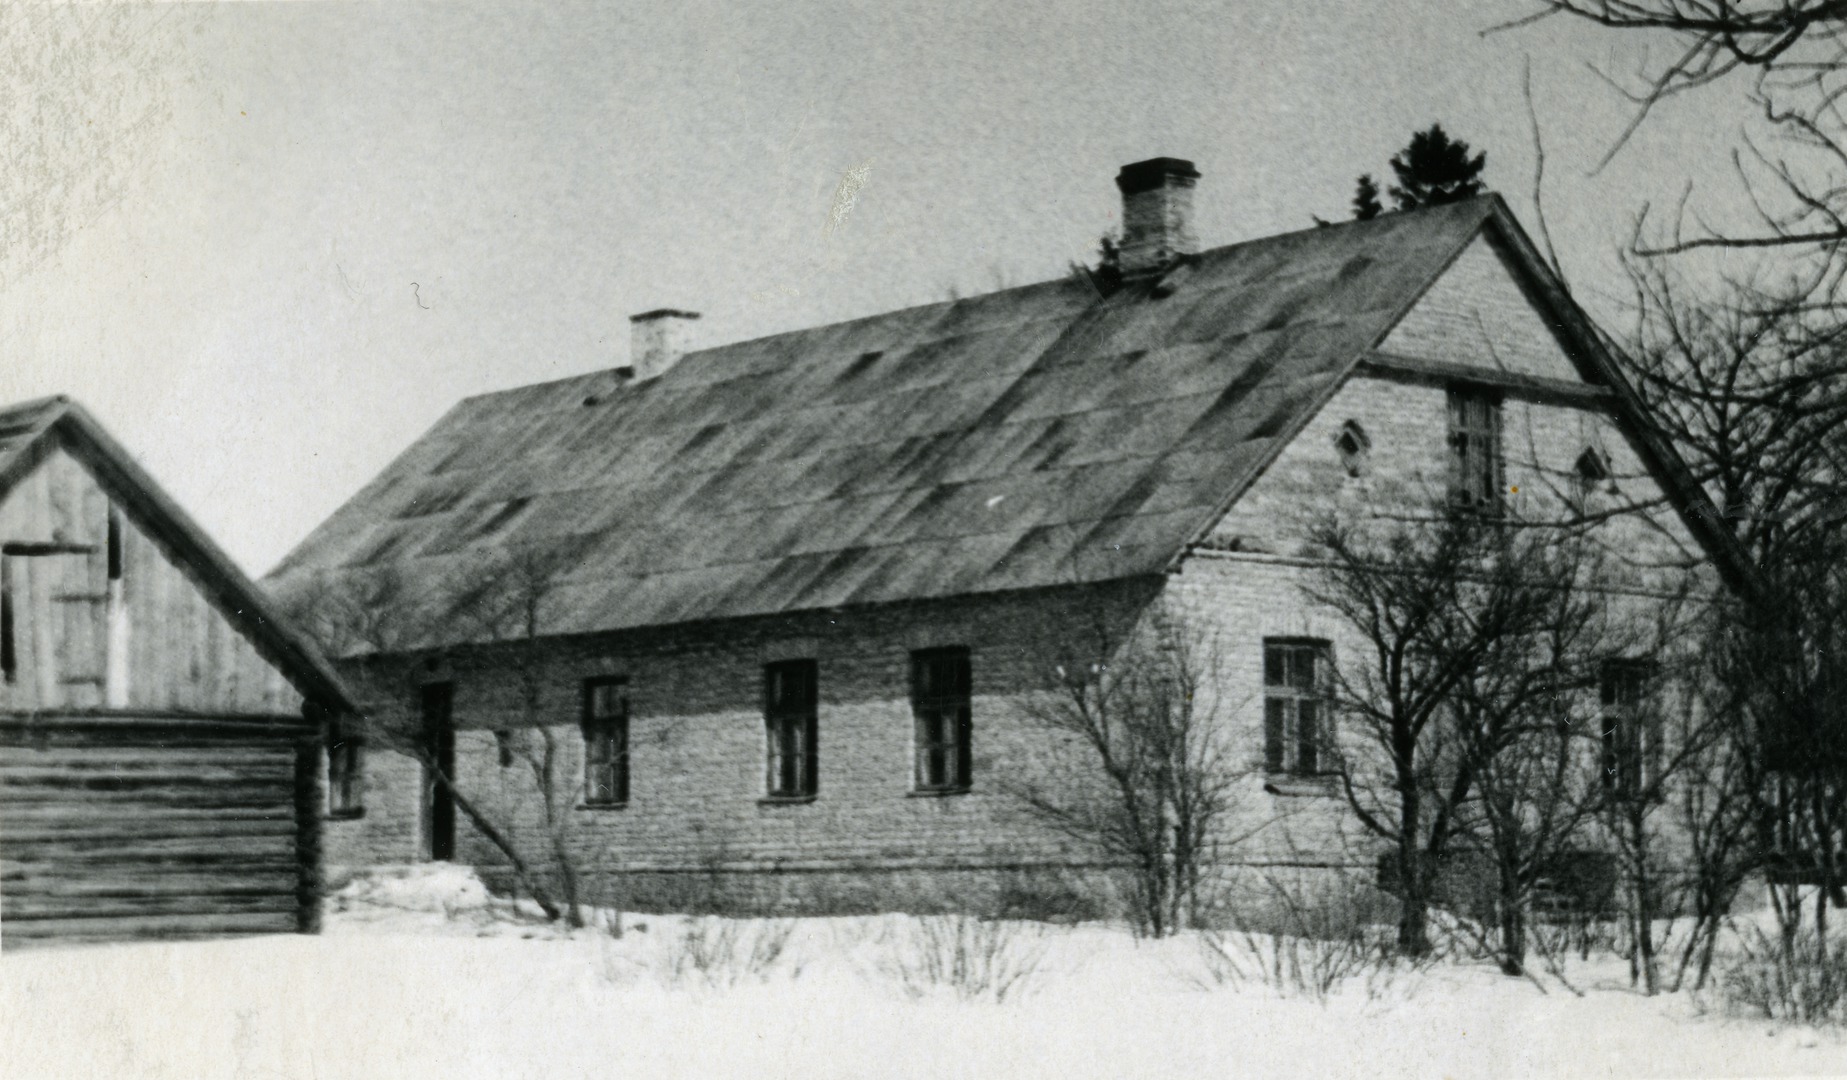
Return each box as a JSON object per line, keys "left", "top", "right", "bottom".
{"left": 0, "top": 868, "right": 1847, "bottom": 1080}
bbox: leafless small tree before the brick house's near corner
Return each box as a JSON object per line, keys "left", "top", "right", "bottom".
{"left": 1014, "top": 602, "right": 1252, "bottom": 938}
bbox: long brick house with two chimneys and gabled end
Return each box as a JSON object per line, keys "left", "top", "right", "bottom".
{"left": 270, "top": 159, "right": 1736, "bottom": 906}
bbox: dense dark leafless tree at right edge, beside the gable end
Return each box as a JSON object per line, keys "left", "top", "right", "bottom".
{"left": 1625, "top": 260, "right": 1847, "bottom": 945}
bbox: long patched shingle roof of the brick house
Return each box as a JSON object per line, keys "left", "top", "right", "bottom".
{"left": 270, "top": 196, "right": 1736, "bottom": 648}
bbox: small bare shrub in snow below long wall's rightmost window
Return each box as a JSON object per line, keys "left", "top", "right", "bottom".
{"left": 877, "top": 914, "right": 1045, "bottom": 1002}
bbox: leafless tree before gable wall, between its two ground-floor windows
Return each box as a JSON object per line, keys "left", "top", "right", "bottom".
{"left": 1302, "top": 502, "right": 1609, "bottom": 952}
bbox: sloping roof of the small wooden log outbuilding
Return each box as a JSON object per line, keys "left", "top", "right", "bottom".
{"left": 0, "top": 397, "right": 349, "bottom": 709}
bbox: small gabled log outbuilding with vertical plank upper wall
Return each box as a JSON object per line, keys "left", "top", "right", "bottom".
{"left": 0, "top": 397, "right": 345, "bottom": 947}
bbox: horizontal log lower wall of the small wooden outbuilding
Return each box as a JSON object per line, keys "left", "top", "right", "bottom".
{"left": 0, "top": 713, "right": 320, "bottom": 947}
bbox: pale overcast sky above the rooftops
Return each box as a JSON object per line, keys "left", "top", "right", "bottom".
{"left": 0, "top": 0, "right": 1744, "bottom": 574}
